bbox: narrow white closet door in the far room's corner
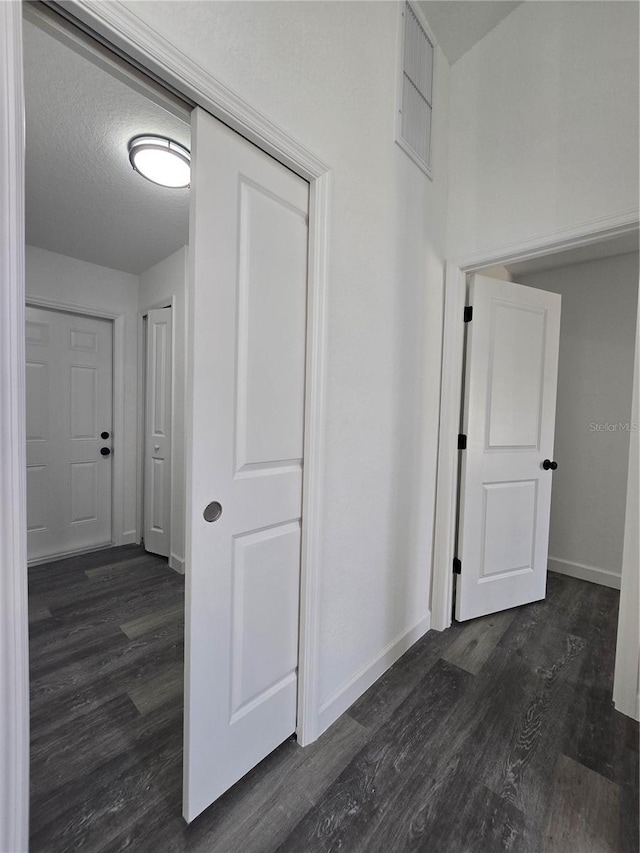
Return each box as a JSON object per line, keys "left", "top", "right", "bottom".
{"left": 144, "top": 308, "right": 172, "bottom": 557}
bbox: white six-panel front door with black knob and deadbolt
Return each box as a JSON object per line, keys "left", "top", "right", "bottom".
{"left": 26, "top": 307, "right": 113, "bottom": 560}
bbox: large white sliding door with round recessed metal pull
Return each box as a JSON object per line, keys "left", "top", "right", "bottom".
{"left": 184, "top": 109, "right": 309, "bottom": 821}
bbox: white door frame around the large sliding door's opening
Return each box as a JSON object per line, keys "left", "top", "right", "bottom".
{"left": 2, "top": 3, "right": 330, "bottom": 843}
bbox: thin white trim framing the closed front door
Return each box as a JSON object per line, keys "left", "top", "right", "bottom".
{"left": 25, "top": 293, "right": 128, "bottom": 544}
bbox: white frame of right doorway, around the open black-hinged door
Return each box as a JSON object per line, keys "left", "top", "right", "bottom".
{"left": 431, "top": 211, "right": 639, "bottom": 631}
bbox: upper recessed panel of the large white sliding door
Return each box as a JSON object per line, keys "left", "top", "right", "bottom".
{"left": 236, "top": 179, "right": 307, "bottom": 471}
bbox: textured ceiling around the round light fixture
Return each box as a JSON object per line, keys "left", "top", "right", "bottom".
{"left": 24, "top": 21, "right": 190, "bottom": 274}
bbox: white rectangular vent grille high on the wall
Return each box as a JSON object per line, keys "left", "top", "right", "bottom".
{"left": 398, "top": 3, "right": 434, "bottom": 172}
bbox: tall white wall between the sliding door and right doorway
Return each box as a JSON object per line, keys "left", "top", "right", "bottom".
{"left": 126, "top": 2, "right": 448, "bottom": 728}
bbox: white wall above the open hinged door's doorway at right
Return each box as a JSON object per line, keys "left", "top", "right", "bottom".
{"left": 449, "top": 0, "right": 638, "bottom": 261}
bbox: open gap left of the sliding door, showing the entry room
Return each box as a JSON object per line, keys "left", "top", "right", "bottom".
{"left": 23, "top": 4, "right": 190, "bottom": 849}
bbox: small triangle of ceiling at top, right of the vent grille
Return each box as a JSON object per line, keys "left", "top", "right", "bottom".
{"left": 417, "top": 0, "right": 520, "bottom": 65}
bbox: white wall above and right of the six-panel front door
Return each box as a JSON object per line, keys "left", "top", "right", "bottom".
{"left": 26, "top": 246, "right": 138, "bottom": 545}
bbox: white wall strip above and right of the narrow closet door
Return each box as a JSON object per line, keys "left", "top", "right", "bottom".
{"left": 139, "top": 246, "right": 188, "bottom": 572}
